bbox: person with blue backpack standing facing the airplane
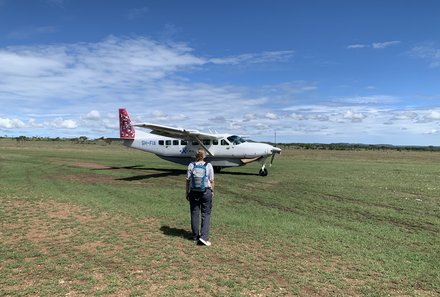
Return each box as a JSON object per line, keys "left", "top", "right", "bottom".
{"left": 186, "top": 148, "right": 214, "bottom": 246}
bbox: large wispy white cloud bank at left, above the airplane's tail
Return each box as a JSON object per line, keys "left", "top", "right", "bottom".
{"left": 0, "top": 37, "right": 206, "bottom": 100}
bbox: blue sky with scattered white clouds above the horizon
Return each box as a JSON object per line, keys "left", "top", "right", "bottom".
{"left": 0, "top": 0, "right": 440, "bottom": 145}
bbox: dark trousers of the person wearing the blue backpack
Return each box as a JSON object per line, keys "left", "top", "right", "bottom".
{"left": 189, "top": 189, "right": 212, "bottom": 241}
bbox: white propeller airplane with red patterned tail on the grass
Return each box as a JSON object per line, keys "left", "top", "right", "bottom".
{"left": 111, "top": 108, "right": 281, "bottom": 176}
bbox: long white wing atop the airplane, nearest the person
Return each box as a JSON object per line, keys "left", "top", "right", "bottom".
{"left": 134, "top": 123, "right": 222, "bottom": 141}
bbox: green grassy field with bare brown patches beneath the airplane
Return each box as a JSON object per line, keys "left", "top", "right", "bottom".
{"left": 0, "top": 140, "right": 440, "bottom": 296}
